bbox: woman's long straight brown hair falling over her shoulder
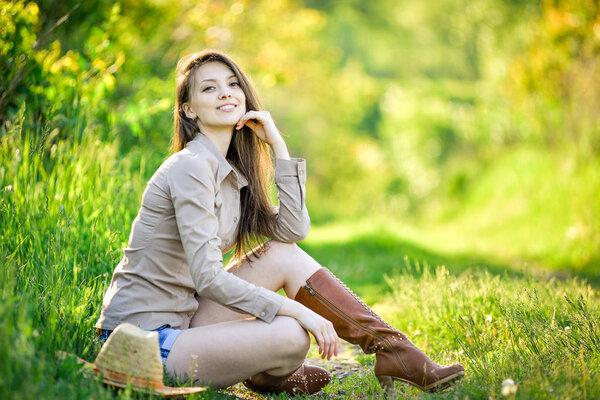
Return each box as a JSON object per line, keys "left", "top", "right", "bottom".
{"left": 172, "top": 50, "right": 275, "bottom": 260}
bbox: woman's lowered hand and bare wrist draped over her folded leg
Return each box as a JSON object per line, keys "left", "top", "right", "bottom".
{"left": 279, "top": 299, "right": 338, "bottom": 360}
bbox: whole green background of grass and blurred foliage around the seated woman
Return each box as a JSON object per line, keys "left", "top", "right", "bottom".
{"left": 0, "top": 0, "right": 600, "bottom": 398}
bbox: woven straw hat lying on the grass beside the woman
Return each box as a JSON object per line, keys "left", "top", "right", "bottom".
{"left": 66, "top": 323, "right": 206, "bottom": 396}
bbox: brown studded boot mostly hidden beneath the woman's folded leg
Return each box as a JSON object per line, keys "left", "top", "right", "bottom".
{"left": 243, "top": 364, "right": 331, "bottom": 396}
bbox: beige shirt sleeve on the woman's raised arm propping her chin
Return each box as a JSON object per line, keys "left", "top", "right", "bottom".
{"left": 271, "top": 158, "right": 310, "bottom": 243}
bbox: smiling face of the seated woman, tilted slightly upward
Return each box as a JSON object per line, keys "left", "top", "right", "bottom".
{"left": 184, "top": 61, "right": 246, "bottom": 133}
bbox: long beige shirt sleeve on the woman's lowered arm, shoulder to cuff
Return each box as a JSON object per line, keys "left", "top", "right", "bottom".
{"left": 167, "top": 155, "right": 283, "bottom": 322}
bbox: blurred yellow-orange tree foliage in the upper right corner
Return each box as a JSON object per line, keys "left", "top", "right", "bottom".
{"left": 507, "top": 0, "right": 600, "bottom": 157}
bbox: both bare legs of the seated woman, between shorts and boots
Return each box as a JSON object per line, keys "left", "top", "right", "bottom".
{"left": 167, "top": 241, "right": 321, "bottom": 387}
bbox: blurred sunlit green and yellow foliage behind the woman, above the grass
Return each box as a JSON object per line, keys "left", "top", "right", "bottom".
{"left": 0, "top": 0, "right": 600, "bottom": 278}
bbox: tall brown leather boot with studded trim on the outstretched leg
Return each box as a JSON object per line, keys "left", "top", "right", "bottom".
{"left": 296, "top": 268, "right": 465, "bottom": 392}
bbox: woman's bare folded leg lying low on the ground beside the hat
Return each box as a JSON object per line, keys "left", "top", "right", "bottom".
{"left": 166, "top": 316, "right": 310, "bottom": 387}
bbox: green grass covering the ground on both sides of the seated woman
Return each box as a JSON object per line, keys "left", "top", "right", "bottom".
{"left": 0, "top": 128, "right": 600, "bottom": 399}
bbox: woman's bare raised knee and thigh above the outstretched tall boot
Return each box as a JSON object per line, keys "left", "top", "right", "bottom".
{"left": 190, "top": 240, "right": 321, "bottom": 328}
